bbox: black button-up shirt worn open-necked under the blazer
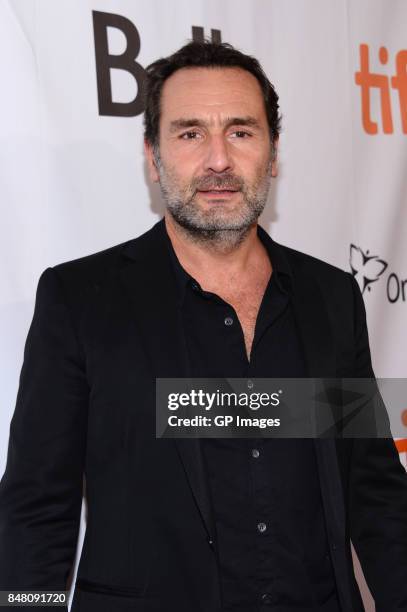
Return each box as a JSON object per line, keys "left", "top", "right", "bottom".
{"left": 166, "top": 226, "right": 339, "bottom": 612}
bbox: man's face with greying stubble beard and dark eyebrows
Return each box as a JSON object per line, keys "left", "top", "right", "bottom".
{"left": 146, "top": 68, "right": 277, "bottom": 236}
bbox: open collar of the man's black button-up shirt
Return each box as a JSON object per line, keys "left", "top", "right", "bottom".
{"left": 163, "top": 220, "right": 292, "bottom": 303}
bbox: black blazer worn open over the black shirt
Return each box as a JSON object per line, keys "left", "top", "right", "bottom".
{"left": 0, "top": 220, "right": 407, "bottom": 612}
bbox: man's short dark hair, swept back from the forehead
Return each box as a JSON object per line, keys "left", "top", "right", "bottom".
{"left": 144, "top": 39, "right": 281, "bottom": 150}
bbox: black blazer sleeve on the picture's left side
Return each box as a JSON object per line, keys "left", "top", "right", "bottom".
{"left": 0, "top": 268, "right": 88, "bottom": 610}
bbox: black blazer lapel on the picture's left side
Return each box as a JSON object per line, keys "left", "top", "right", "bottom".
{"left": 120, "top": 219, "right": 215, "bottom": 543}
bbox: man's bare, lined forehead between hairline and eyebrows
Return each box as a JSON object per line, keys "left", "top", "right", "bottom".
{"left": 161, "top": 68, "right": 266, "bottom": 123}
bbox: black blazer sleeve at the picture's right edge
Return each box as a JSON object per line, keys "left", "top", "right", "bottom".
{"left": 349, "top": 277, "right": 407, "bottom": 612}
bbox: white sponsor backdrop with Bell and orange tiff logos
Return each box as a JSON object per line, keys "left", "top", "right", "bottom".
{"left": 0, "top": 0, "right": 407, "bottom": 610}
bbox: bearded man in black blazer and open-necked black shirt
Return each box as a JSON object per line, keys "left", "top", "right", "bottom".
{"left": 0, "top": 42, "right": 407, "bottom": 612}
